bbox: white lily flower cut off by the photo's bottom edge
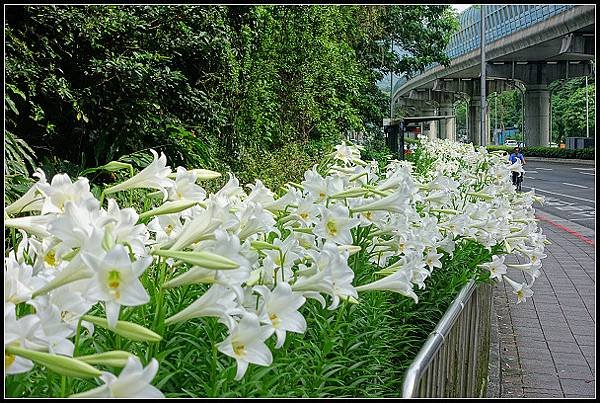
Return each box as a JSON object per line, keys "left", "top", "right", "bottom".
{"left": 70, "top": 357, "right": 165, "bottom": 399}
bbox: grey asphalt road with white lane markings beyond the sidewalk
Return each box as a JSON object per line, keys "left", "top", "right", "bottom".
{"left": 523, "top": 160, "right": 596, "bottom": 231}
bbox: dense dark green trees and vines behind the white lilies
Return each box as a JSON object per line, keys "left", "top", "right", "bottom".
{"left": 5, "top": 5, "right": 457, "bottom": 183}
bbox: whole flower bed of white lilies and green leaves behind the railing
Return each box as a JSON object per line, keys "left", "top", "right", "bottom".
{"left": 5, "top": 141, "right": 545, "bottom": 397}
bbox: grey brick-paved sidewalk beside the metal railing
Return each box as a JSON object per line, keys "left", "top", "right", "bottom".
{"left": 488, "top": 211, "right": 596, "bottom": 398}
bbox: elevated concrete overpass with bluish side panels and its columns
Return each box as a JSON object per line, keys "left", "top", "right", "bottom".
{"left": 393, "top": 5, "right": 595, "bottom": 146}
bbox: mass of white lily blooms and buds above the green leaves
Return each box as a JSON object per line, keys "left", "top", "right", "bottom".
{"left": 4, "top": 140, "right": 547, "bottom": 397}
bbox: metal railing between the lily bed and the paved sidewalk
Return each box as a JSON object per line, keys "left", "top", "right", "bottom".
{"left": 402, "top": 280, "right": 492, "bottom": 397}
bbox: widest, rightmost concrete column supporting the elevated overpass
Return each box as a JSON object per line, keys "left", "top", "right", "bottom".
{"left": 525, "top": 85, "right": 550, "bottom": 147}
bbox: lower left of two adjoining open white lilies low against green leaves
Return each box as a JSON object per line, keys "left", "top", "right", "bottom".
{"left": 217, "top": 313, "right": 273, "bottom": 381}
